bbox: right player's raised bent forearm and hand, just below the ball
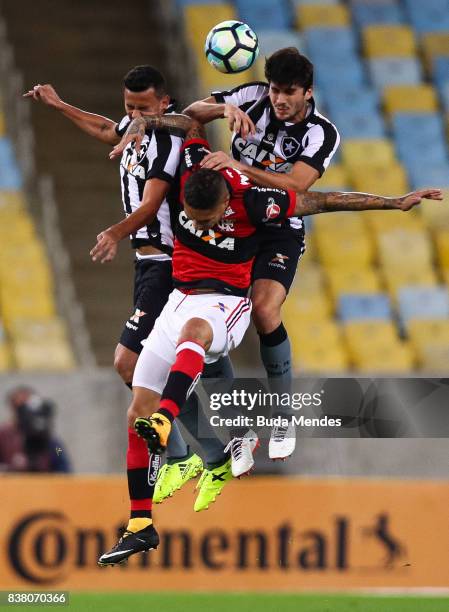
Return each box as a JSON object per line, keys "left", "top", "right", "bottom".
{"left": 183, "top": 96, "right": 252, "bottom": 138}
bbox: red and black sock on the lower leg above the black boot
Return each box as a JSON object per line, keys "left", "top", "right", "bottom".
{"left": 126, "top": 429, "right": 156, "bottom": 518}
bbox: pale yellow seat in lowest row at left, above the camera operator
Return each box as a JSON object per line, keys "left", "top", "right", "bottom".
{"left": 13, "top": 341, "right": 75, "bottom": 372}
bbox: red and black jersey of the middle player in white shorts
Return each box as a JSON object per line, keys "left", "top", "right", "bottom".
{"left": 173, "top": 139, "right": 296, "bottom": 295}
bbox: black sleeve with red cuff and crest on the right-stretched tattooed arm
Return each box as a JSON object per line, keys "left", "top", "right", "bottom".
{"left": 243, "top": 186, "right": 296, "bottom": 225}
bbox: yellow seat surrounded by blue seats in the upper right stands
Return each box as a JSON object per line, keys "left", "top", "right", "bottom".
{"left": 384, "top": 84, "right": 438, "bottom": 114}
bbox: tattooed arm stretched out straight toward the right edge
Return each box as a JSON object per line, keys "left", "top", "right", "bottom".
{"left": 293, "top": 189, "right": 443, "bottom": 216}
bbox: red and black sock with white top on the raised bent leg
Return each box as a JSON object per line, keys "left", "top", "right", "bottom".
{"left": 159, "top": 340, "right": 206, "bottom": 421}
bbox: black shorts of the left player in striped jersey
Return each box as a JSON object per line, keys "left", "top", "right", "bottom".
{"left": 119, "top": 259, "right": 173, "bottom": 355}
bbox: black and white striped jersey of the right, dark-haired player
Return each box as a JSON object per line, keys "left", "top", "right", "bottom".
{"left": 212, "top": 82, "right": 340, "bottom": 229}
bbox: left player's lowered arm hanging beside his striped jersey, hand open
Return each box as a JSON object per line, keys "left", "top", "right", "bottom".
{"left": 90, "top": 178, "right": 170, "bottom": 263}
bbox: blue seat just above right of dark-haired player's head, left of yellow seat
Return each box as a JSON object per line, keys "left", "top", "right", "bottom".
{"left": 304, "top": 28, "right": 357, "bottom": 61}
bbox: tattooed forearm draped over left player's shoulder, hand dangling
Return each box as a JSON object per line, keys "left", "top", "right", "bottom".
{"left": 109, "top": 113, "right": 193, "bottom": 159}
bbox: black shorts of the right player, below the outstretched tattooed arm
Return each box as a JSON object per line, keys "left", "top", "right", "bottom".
{"left": 252, "top": 227, "right": 306, "bottom": 293}
